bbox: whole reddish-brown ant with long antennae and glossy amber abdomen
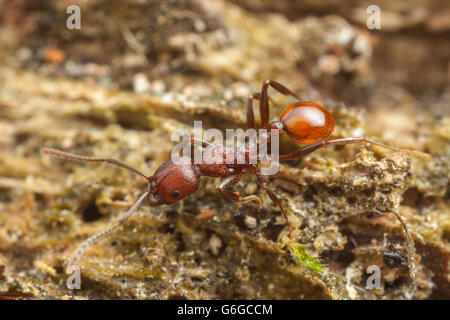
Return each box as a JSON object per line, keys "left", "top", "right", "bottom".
{"left": 41, "top": 80, "right": 429, "bottom": 273}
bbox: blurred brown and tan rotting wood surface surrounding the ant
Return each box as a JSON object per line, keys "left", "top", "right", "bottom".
{"left": 0, "top": 0, "right": 450, "bottom": 299}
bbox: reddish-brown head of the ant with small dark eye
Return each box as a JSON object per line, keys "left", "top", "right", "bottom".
{"left": 147, "top": 157, "right": 199, "bottom": 206}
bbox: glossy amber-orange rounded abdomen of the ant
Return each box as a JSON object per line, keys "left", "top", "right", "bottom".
{"left": 280, "top": 101, "right": 334, "bottom": 144}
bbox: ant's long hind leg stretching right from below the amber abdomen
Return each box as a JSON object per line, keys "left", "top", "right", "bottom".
{"left": 278, "top": 138, "right": 430, "bottom": 160}
